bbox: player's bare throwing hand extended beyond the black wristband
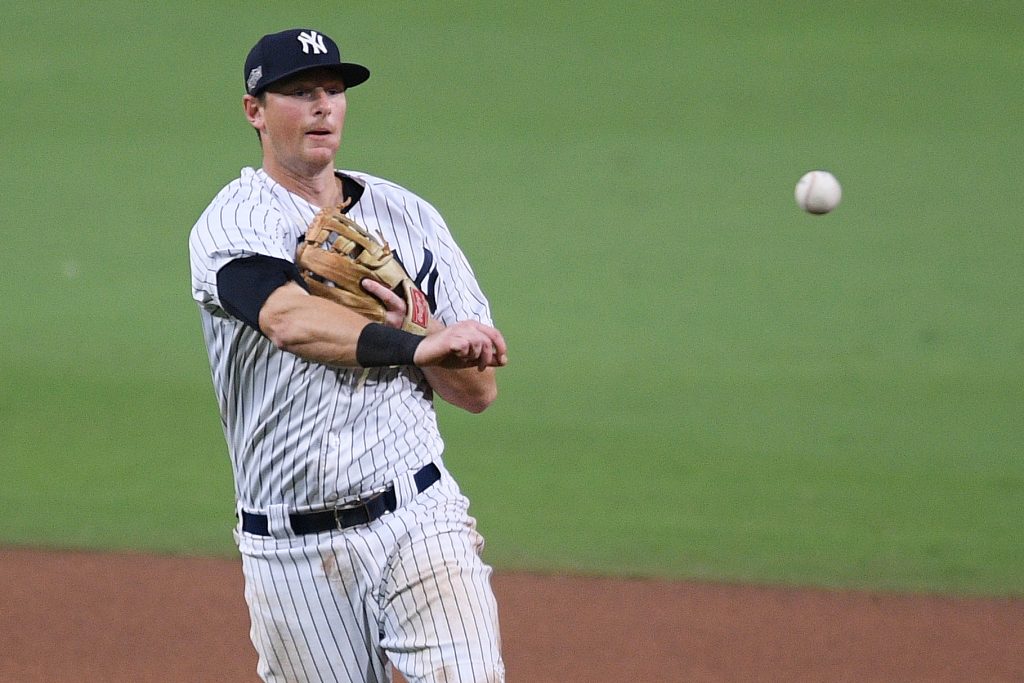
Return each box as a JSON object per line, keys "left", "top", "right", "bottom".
{"left": 415, "top": 321, "right": 509, "bottom": 370}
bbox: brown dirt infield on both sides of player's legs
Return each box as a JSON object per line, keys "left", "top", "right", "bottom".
{"left": 0, "top": 549, "right": 1024, "bottom": 683}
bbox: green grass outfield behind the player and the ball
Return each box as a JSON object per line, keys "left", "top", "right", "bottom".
{"left": 0, "top": 0, "right": 1024, "bottom": 595}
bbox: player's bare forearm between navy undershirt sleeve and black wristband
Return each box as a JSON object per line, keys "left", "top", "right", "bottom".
{"left": 259, "top": 284, "right": 369, "bottom": 367}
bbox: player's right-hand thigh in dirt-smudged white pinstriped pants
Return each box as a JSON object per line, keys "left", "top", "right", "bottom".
{"left": 381, "top": 517, "right": 504, "bottom": 683}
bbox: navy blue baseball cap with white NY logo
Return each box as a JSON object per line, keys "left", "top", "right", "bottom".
{"left": 243, "top": 29, "right": 370, "bottom": 95}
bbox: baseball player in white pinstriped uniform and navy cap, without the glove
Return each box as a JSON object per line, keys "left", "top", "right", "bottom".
{"left": 188, "top": 29, "right": 508, "bottom": 683}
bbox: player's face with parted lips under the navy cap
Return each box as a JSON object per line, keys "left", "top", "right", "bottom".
{"left": 250, "top": 70, "right": 347, "bottom": 175}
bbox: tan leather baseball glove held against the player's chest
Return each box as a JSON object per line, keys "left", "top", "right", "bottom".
{"left": 295, "top": 206, "right": 430, "bottom": 335}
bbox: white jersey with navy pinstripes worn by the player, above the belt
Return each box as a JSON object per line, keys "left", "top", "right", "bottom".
{"left": 189, "top": 168, "right": 492, "bottom": 511}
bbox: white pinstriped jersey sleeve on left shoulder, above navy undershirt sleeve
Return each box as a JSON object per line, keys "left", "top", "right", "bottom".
{"left": 188, "top": 176, "right": 296, "bottom": 312}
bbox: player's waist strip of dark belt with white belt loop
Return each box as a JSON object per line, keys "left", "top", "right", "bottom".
{"left": 240, "top": 463, "right": 441, "bottom": 537}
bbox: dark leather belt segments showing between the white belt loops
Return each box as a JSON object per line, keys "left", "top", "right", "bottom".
{"left": 242, "top": 463, "right": 441, "bottom": 536}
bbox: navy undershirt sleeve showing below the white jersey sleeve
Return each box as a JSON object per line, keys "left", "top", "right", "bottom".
{"left": 217, "top": 254, "right": 309, "bottom": 334}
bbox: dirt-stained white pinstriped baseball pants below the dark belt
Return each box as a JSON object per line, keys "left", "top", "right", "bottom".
{"left": 237, "top": 472, "right": 505, "bottom": 683}
